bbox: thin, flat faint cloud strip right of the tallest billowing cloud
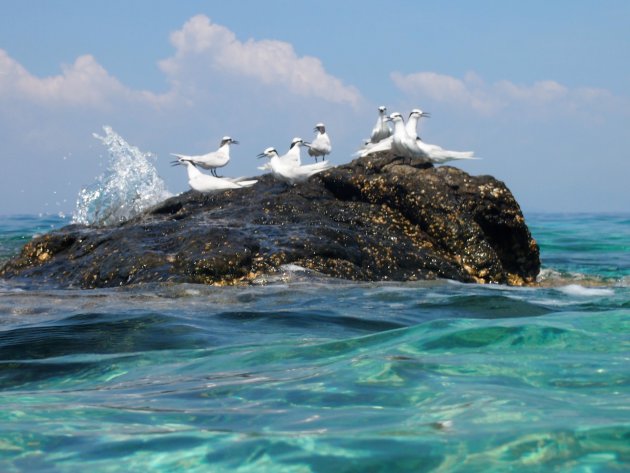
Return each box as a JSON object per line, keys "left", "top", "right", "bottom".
{"left": 391, "top": 72, "right": 612, "bottom": 115}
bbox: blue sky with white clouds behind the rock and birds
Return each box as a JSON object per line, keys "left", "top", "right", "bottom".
{"left": 0, "top": 0, "right": 630, "bottom": 214}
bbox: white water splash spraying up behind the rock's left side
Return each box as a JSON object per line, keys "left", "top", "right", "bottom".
{"left": 72, "top": 126, "right": 172, "bottom": 225}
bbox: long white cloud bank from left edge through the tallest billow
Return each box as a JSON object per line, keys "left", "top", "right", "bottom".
{"left": 0, "top": 15, "right": 362, "bottom": 109}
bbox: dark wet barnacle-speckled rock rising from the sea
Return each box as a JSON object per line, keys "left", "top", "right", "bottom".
{"left": 0, "top": 153, "right": 540, "bottom": 288}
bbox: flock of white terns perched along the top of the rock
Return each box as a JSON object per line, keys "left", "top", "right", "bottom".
{"left": 172, "top": 106, "right": 478, "bottom": 193}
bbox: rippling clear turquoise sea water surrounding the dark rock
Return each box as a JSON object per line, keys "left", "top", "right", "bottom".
{"left": 0, "top": 215, "right": 630, "bottom": 472}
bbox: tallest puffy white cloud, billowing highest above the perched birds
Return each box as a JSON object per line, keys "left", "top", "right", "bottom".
{"left": 160, "top": 15, "right": 361, "bottom": 106}
